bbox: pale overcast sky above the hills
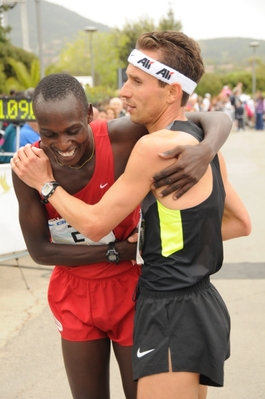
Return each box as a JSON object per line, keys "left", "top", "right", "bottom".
{"left": 49, "top": 0, "right": 265, "bottom": 40}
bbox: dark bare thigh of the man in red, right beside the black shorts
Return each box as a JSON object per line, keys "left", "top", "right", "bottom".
{"left": 113, "top": 342, "right": 137, "bottom": 399}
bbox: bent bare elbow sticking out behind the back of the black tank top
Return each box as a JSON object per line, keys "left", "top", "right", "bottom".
{"left": 218, "top": 153, "right": 251, "bottom": 241}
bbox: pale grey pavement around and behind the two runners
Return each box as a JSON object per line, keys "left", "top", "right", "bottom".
{"left": 0, "top": 130, "right": 265, "bottom": 399}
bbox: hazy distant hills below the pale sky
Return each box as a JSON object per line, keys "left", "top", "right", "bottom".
{"left": 6, "top": 0, "right": 265, "bottom": 69}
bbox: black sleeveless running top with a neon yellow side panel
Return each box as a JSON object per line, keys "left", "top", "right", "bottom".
{"left": 139, "top": 121, "right": 225, "bottom": 291}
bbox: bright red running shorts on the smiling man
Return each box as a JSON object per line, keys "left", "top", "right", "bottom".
{"left": 48, "top": 266, "right": 140, "bottom": 346}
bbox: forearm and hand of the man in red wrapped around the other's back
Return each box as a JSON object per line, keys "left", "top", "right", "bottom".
{"left": 152, "top": 112, "right": 232, "bottom": 199}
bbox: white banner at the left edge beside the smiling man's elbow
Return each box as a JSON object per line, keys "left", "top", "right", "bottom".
{"left": 0, "top": 164, "right": 26, "bottom": 257}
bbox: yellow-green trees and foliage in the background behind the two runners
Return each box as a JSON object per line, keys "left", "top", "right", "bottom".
{"left": 0, "top": 6, "right": 265, "bottom": 103}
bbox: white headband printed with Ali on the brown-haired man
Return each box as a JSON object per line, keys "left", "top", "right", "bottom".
{"left": 128, "top": 49, "right": 197, "bottom": 94}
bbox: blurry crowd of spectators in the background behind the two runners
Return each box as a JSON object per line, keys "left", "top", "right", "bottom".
{"left": 0, "top": 82, "right": 265, "bottom": 163}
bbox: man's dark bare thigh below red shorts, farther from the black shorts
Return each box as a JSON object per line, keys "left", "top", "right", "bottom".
{"left": 62, "top": 339, "right": 110, "bottom": 399}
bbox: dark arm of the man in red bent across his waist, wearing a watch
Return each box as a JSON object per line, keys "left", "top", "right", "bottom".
{"left": 13, "top": 173, "right": 136, "bottom": 266}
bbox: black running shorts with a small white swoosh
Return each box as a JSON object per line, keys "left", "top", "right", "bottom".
{"left": 133, "top": 278, "right": 230, "bottom": 386}
